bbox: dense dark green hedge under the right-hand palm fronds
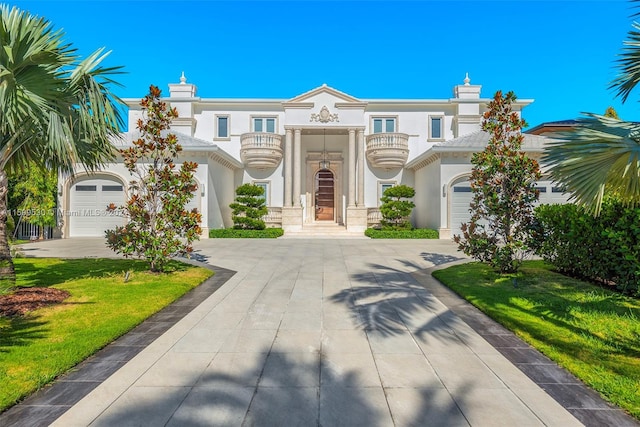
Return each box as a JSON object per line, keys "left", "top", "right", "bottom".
{"left": 535, "top": 200, "right": 640, "bottom": 294}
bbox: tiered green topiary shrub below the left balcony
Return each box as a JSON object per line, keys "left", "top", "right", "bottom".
{"left": 229, "top": 184, "right": 268, "bottom": 230}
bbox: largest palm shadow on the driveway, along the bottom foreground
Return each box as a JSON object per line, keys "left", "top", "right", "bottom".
{"left": 99, "top": 348, "right": 385, "bottom": 427}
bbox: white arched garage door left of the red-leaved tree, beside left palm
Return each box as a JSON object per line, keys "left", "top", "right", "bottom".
{"left": 66, "top": 178, "right": 125, "bottom": 237}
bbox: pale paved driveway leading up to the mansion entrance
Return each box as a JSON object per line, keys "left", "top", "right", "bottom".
{"left": 16, "top": 239, "right": 580, "bottom": 427}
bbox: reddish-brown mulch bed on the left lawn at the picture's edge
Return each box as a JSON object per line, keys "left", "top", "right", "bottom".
{"left": 0, "top": 287, "right": 71, "bottom": 317}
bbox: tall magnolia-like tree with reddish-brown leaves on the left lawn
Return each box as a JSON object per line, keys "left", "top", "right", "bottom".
{"left": 106, "top": 85, "right": 202, "bottom": 272}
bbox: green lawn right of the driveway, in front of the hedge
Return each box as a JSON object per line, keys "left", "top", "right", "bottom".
{"left": 433, "top": 261, "right": 640, "bottom": 419}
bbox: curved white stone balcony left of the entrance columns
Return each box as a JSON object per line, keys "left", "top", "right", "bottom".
{"left": 240, "top": 132, "right": 282, "bottom": 169}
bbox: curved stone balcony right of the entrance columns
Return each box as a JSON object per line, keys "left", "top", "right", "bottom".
{"left": 367, "top": 132, "right": 409, "bottom": 169}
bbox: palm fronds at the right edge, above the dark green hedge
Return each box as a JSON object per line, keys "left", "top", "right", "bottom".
{"left": 543, "top": 0, "right": 640, "bottom": 215}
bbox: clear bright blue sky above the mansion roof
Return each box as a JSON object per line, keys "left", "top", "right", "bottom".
{"left": 8, "top": 0, "right": 640, "bottom": 126}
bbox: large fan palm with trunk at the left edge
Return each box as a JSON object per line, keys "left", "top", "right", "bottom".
{"left": 0, "top": 5, "right": 123, "bottom": 283}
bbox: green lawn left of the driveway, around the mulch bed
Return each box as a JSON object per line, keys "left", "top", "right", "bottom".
{"left": 0, "top": 258, "right": 212, "bottom": 411}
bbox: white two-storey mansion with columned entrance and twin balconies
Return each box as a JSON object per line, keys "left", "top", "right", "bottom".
{"left": 59, "top": 74, "right": 566, "bottom": 239}
